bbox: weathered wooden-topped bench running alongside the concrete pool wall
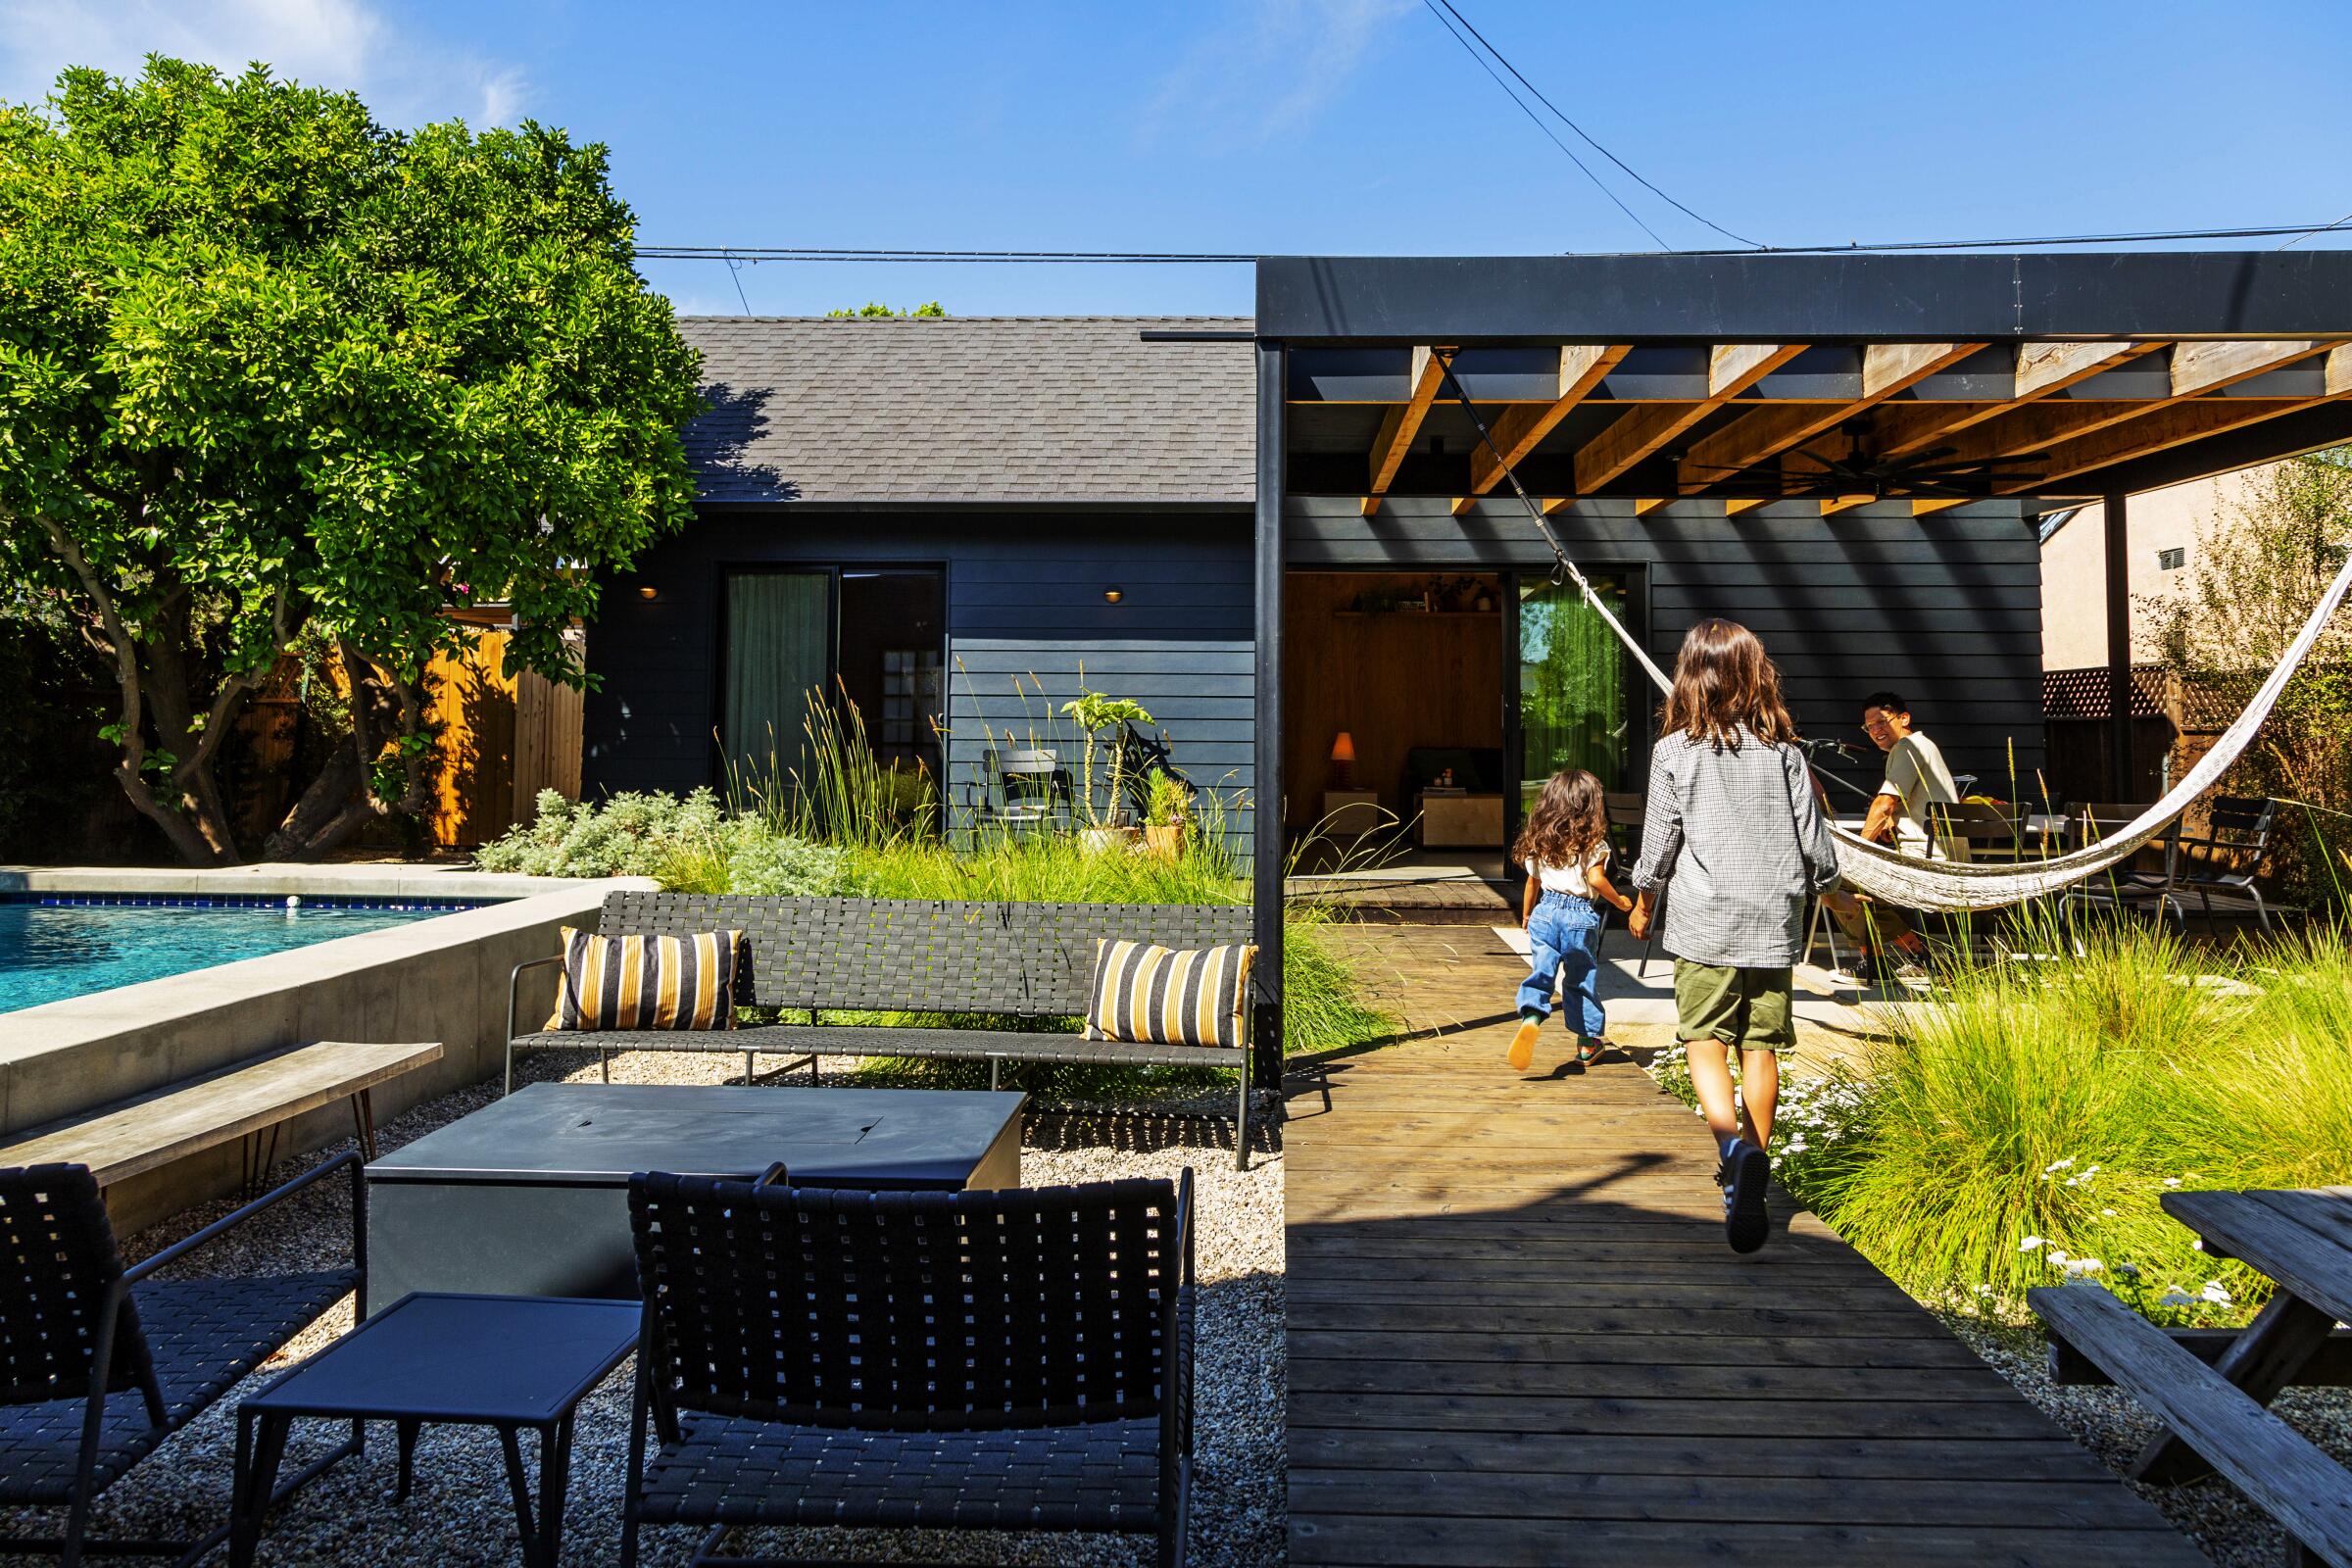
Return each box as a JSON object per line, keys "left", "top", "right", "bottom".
{"left": 0, "top": 1039, "right": 442, "bottom": 1195}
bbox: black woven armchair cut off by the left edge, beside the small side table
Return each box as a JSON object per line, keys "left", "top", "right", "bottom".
{"left": 0, "top": 1152, "right": 365, "bottom": 1568}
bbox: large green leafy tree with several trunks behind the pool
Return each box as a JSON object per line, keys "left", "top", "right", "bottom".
{"left": 0, "top": 57, "right": 699, "bottom": 862}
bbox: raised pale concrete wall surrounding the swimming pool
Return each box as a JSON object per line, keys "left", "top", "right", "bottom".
{"left": 0, "top": 865, "right": 654, "bottom": 1232}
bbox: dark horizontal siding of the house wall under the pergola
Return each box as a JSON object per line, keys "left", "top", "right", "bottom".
{"left": 1284, "top": 496, "right": 2044, "bottom": 795}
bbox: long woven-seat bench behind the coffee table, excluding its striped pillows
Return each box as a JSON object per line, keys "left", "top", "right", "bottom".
{"left": 506, "top": 894, "right": 1265, "bottom": 1168}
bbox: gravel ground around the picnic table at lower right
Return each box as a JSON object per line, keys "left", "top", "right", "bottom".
{"left": 1938, "top": 1312, "right": 2352, "bottom": 1568}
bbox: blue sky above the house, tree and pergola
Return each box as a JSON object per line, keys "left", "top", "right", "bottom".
{"left": 0, "top": 0, "right": 2352, "bottom": 315}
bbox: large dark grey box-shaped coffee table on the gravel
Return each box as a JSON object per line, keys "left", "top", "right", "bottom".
{"left": 367, "top": 1084, "right": 1028, "bottom": 1304}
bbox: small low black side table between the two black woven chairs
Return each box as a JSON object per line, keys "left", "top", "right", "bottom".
{"left": 228, "top": 1293, "right": 640, "bottom": 1568}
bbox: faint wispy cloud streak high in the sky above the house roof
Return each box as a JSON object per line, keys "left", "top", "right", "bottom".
{"left": 1141, "top": 0, "right": 1416, "bottom": 148}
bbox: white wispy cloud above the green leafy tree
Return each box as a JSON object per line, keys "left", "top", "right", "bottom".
{"left": 0, "top": 0, "right": 529, "bottom": 129}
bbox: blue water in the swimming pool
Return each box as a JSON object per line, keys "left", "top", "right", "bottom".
{"left": 0, "top": 898, "right": 475, "bottom": 1013}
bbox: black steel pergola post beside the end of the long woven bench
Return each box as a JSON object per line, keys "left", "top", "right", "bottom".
{"left": 1251, "top": 343, "right": 1289, "bottom": 1093}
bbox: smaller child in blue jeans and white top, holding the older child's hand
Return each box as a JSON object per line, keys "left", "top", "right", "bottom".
{"left": 1510, "top": 768, "right": 1633, "bottom": 1072}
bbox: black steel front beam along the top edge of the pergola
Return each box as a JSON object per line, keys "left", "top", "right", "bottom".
{"left": 1256, "top": 249, "right": 2352, "bottom": 346}
